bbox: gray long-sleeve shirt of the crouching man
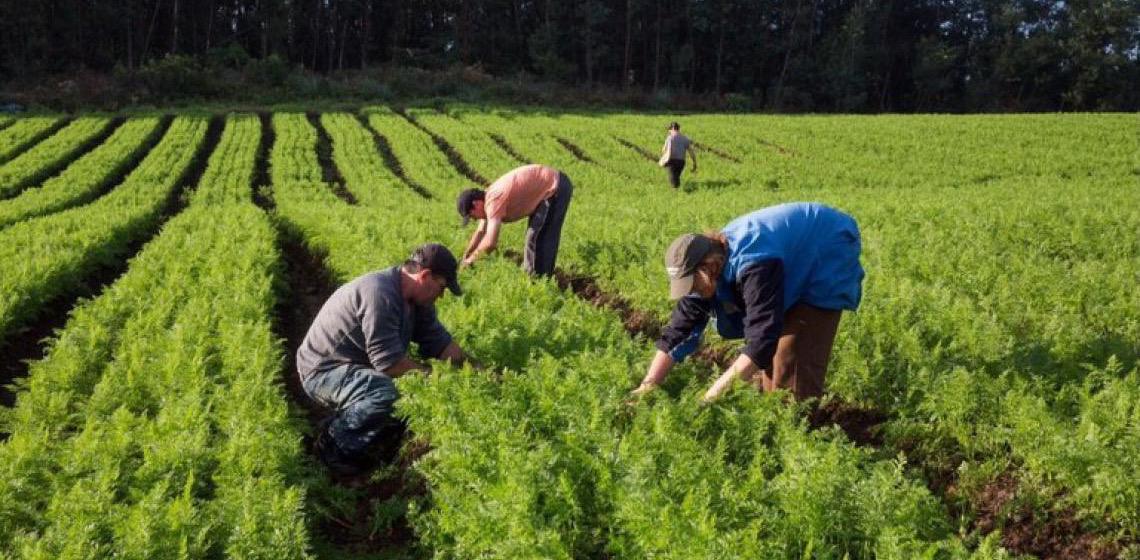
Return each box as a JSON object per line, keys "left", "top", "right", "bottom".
{"left": 296, "top": 267, "right": 451, "bottom": 375}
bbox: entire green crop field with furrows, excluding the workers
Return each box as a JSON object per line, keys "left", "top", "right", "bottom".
{"left": 0, "top": 105, "right": 1140, "bottom": 560}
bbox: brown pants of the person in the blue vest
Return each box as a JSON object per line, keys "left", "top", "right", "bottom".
{"left": 752, "top": 303, "right": 842, "bottom": 400}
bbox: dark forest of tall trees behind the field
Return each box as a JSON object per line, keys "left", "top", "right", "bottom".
{"left": 0, "top": 0, "right": 1140, "bottom": 112}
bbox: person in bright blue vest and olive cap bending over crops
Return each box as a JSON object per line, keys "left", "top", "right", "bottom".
{"left": 633, "top": 203, "right": 863, "bottom": 403}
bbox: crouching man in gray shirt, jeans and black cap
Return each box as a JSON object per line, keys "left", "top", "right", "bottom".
{"left": 296, "top": 244, "right": 466, "bottom": 476}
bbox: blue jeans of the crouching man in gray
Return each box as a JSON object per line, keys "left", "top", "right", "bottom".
{"left": 301, "top": 364, "right": 400, "bottom": 455}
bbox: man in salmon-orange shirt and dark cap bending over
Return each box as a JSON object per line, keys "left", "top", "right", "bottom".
{"left": 457, "top": 161, "right": 573, "bottom": 276}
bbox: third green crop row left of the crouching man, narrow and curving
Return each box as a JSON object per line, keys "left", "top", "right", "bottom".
{"left": 0, "top": 116, "right": 161, "bottom": 228}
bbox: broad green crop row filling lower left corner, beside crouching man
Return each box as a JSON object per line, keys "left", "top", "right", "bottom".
{"left": 0, "top": 116, "right": 309, "bottom": 559}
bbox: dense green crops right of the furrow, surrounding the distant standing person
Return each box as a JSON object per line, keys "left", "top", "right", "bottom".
{"left": 418, "top": 108, "right": 1140, "bottom": 535}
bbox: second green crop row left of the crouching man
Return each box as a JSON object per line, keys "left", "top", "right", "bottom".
{"left": 0, "top": 116, "right": 207, "bottom": 333}
